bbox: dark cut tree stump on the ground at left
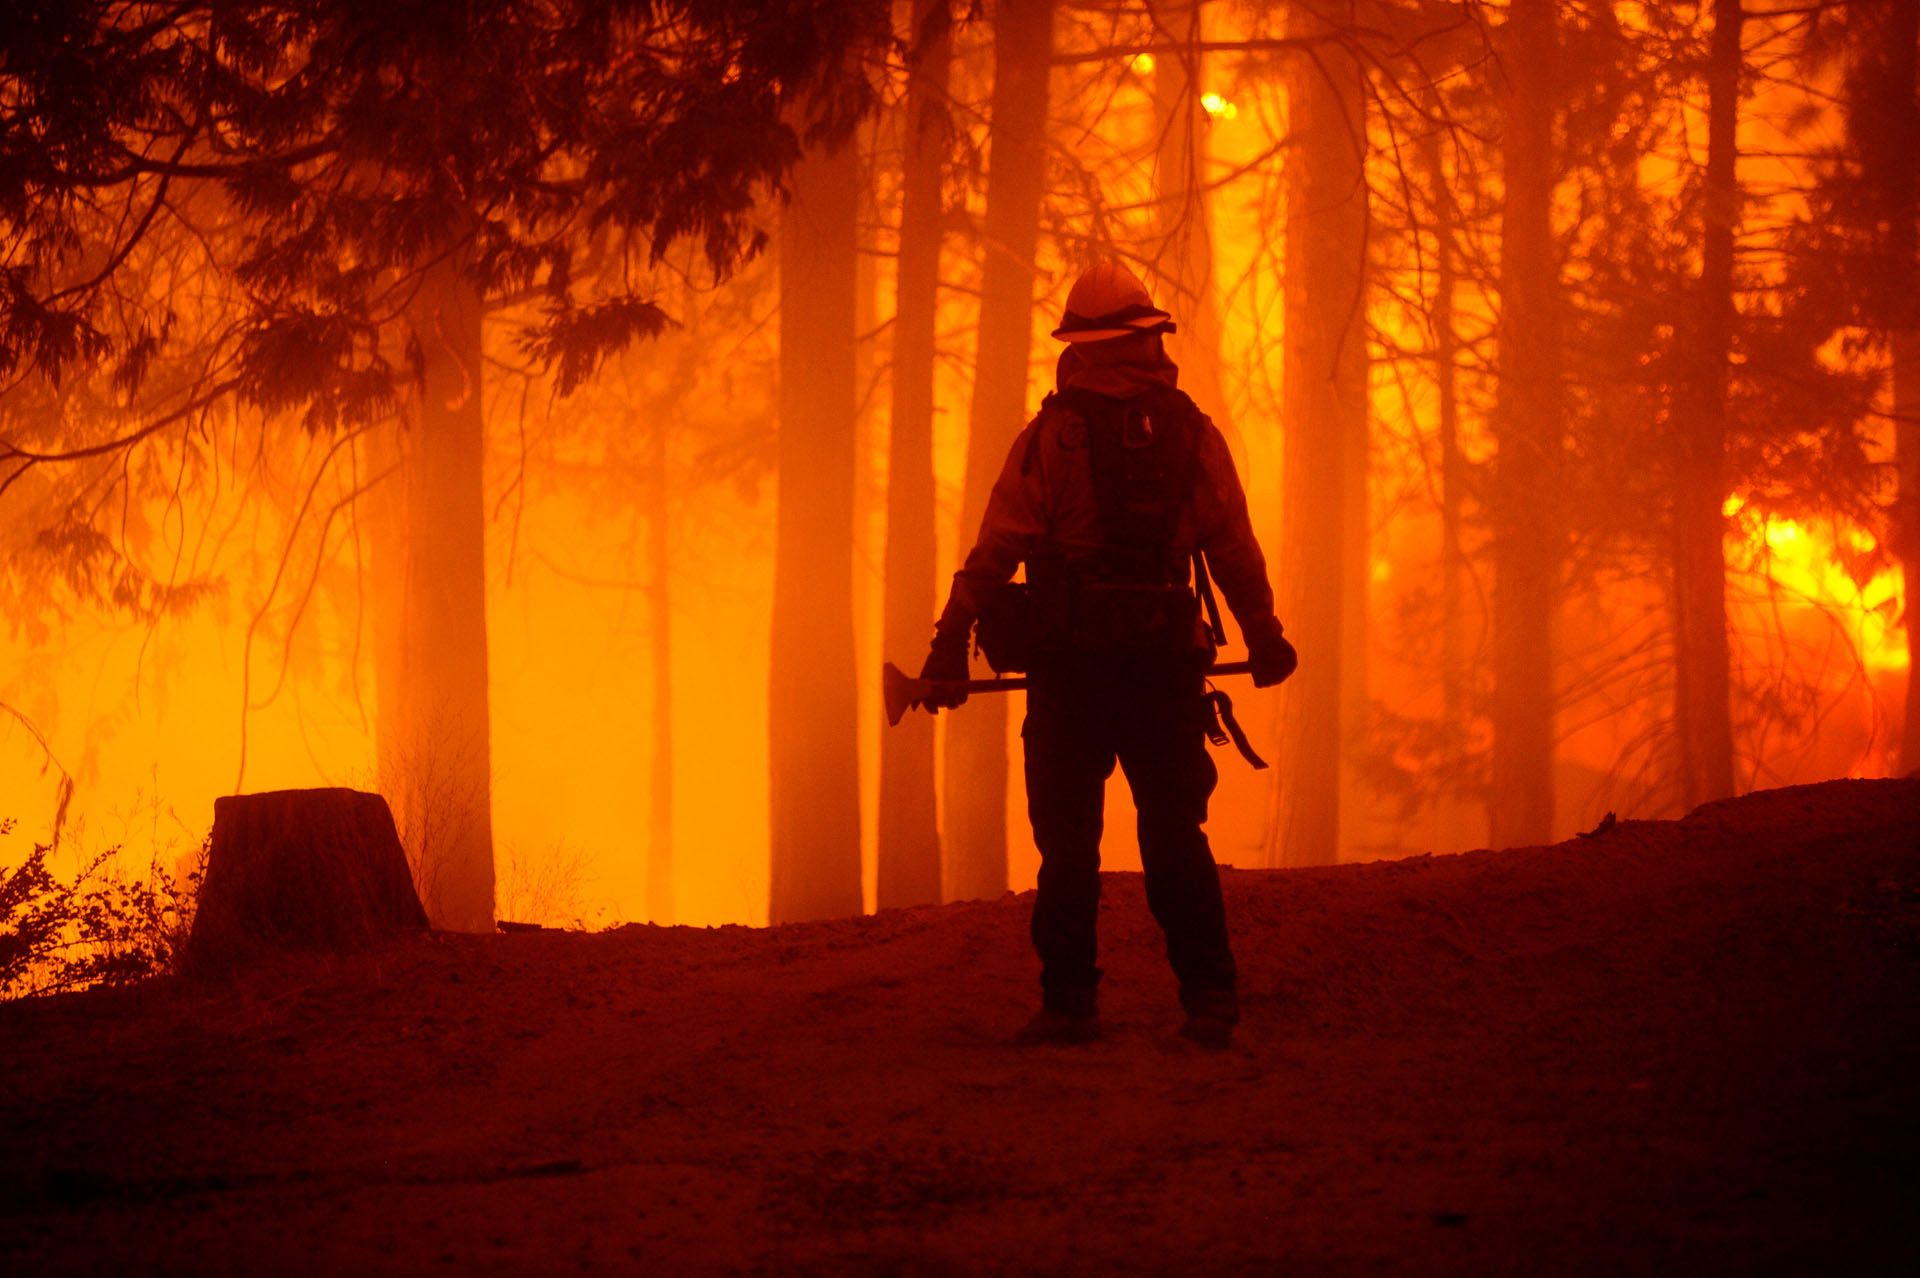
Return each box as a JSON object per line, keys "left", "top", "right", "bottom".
{"left": 184, "top": 789, "right": 426, "bottom": 975}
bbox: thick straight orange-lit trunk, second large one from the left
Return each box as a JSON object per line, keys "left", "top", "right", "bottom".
{"left": 768, "top": 134, "right": 862, "bottom": 923}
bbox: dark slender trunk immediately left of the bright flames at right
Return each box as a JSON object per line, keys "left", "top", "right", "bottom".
{"left": 1672, "top": 0, "right": 1741, "bottom": 808}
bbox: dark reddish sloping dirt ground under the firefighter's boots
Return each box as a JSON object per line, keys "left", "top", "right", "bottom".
{"left": 0, "top": 779, "right": 1920, "bottom": 1276}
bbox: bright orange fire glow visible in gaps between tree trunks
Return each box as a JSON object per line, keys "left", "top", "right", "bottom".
{"left": 0, "top": 6, "right": 1910, "bottom": 925}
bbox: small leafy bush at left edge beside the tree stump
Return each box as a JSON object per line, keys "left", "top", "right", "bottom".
{"left": 0, "top": 819, "right": 205, "bottom": 1000}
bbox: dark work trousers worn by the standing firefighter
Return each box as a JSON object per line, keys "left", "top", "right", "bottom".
{"left": 1021, "top": 658, "right": 1235, "bottom": 1015}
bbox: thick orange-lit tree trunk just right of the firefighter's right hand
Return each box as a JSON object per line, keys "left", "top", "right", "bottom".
{"left": 1267, "top": 14, "right": 1367, "bottom": 865}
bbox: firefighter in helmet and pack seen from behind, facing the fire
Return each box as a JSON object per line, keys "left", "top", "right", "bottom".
{"left": 922, "top": 263, "right": 1298, "bottom": 1048}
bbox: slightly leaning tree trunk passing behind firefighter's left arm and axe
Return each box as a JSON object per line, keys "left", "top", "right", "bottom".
{"left": 945, "top": 0, "right": 1054, "bottom": 900}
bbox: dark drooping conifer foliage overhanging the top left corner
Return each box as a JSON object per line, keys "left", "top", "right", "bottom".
{"left": 0, "top": 0, "right": 885, "bottom": 435}
